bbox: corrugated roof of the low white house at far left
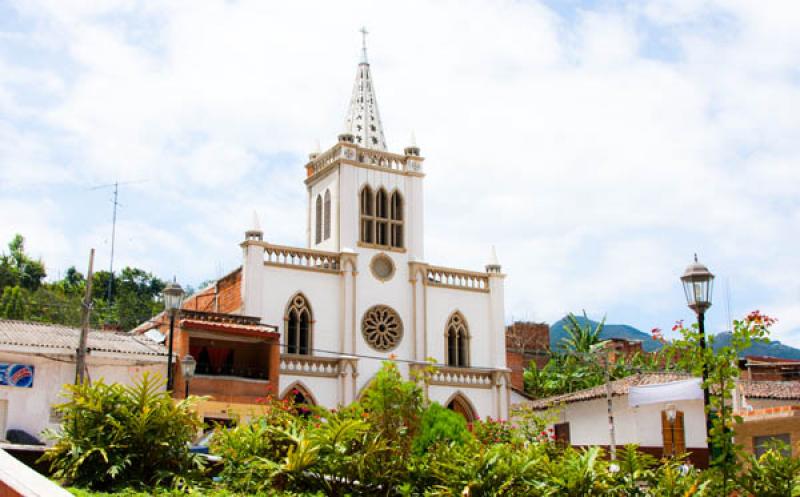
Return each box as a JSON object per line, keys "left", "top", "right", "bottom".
{"left": 0, "top": 319, "right": 167, "bottom": 357}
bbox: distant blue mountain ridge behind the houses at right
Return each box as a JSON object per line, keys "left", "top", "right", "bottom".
{"left": 550, "top": 315, "right": 800, "bottom": 359}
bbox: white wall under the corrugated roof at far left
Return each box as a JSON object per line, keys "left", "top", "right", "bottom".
{"left": 0, "top": 352, "right": 166, "bottom": 442}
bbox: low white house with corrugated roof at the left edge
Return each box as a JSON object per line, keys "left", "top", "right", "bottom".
{"left": 0, "top": 320, "right": 167, "bottom": 440}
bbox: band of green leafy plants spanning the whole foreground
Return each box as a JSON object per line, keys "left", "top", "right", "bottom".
{"left": 46, "top": 363, "right": 800, "bottom": 497}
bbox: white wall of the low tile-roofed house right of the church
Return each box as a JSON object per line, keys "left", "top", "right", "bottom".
{"left": 559, "top": 395, "right": 706, "bottom": 448}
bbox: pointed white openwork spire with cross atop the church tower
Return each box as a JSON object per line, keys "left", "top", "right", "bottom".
{"left": 344, "top": 28, "right": 386, "bottom": 150}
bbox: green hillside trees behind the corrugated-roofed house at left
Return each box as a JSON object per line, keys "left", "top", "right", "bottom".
{"left": 0, "top": 235, "right": 165, "bottom": 330}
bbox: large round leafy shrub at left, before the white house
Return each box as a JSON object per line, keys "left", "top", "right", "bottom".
{"left": 42, "top": 373, "right": 203, "bottom": 489}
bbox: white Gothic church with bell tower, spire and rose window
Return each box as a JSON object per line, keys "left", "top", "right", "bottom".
{"left": 176, "top": 44, "right": 510, "bottom": 419}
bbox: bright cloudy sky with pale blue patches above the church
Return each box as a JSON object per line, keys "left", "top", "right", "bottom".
{"left": 0, "top": 0, "right": 800, "bottom": 346}
